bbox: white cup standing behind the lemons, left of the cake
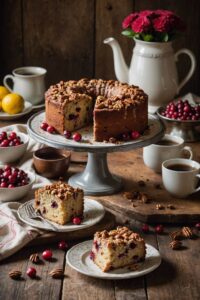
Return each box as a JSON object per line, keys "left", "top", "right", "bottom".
{"left": 3, "top": 67, "right": 47, "bottom": 105}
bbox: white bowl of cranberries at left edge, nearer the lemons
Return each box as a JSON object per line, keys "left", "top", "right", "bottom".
{"left": 0, "top": 131, "right": 29, "bottom": 164}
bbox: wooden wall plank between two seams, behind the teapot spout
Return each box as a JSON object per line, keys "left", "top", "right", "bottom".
{"left": 95, "top": 0, "right": 133, "bottom": 79}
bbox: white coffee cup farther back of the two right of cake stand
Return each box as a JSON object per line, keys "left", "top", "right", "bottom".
{"left": 143, "top": 134, "right": 193, "bottom": 173}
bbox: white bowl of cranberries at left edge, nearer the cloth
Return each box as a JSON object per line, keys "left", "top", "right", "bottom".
{"left": 0, "top": 165, "right": 35, "bottom": 202}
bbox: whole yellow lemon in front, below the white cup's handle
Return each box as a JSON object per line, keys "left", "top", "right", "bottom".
{"left": 2, "top": 93, "right": 24, "bottom": 115}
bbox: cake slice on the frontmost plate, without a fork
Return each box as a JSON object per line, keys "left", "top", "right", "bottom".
{"left": 90, "top": 227, "right": 146, "bottom": 272}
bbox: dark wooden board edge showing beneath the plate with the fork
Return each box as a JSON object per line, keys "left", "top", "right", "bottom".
{"left": 27, "top": 212, "right": 115, "bottom": 247}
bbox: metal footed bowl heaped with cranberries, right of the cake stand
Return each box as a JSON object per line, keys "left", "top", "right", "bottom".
{"left": 157, "top": 99, "right": 200, "bottom": 142}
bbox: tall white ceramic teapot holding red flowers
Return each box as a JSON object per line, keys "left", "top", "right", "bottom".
{"left": 104, "top": 37, "right": 196, "bottom": 113}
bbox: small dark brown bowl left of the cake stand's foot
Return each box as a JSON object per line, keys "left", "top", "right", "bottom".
{"left": 33, "top": 147, "right": 71, "bottom": 178}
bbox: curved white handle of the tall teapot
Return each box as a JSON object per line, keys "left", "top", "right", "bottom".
{"left": 175, "top": 48, "right": 196, "bottom": 94}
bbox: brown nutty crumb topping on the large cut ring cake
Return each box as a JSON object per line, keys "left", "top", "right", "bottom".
{"left": 45, "top": 78, "right": 148, "bottom": 110}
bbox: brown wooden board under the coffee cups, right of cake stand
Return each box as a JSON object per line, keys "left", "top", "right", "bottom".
{"left": 87, "top": 143, "right": 200, "bottom": 224}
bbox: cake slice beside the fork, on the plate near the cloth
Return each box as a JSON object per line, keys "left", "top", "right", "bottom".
{"left": 34, "top": 182, "right": 84, "bottom": 225}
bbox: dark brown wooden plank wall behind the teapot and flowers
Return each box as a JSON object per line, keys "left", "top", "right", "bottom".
{"left": 0, "top": 0, "right": 200, "bottom": 95}
